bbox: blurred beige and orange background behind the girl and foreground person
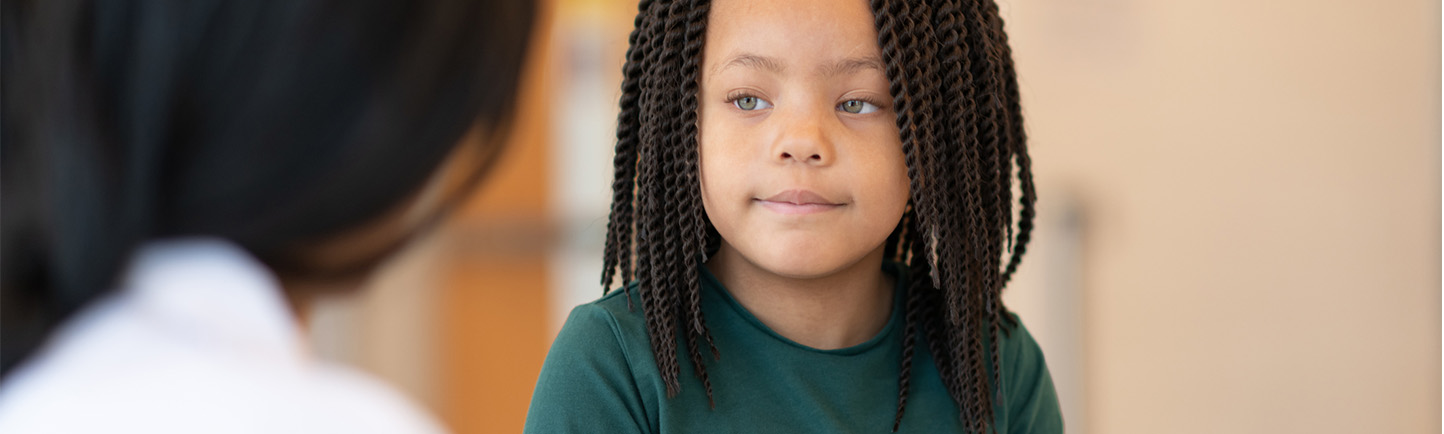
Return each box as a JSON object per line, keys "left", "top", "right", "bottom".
{"left": 298, "top": 0, "right": 1441, "bottom": 434}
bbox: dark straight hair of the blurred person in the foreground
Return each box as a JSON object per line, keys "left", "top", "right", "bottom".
{"left": 0, "top": 0, "right": 534, "bottom": 375}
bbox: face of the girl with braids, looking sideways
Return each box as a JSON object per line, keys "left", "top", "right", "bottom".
{"left": 697, "top": 0, "right": 908, "bottom": 278}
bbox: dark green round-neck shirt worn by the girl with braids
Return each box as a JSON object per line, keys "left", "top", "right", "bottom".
{"left": 526, "top": 264, "right": 1063, "bottom": 434}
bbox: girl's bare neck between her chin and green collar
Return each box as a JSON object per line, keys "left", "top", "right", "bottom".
{"left": 706, "top": 242, "right": 894, "bottom": 349}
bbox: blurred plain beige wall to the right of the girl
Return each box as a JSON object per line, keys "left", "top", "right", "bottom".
{"left": 1004, "top": 0, "right": 1440, "bottom": 433}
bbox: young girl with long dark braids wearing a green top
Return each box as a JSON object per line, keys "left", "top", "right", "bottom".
{"left": 527, "top": 0, "right": 1063, "bottom": 433}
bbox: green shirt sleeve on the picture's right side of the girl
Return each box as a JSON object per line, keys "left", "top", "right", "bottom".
{"left": 1004, "top": 316, "right": 1063, "bottom": 434}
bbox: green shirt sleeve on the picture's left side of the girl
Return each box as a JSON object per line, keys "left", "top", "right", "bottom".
{"left": 524, "top": 304, "right": 650, "bottom": 434}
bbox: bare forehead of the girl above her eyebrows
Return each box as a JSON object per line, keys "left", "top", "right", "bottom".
{"left": 703, "top": 0, "right": 881, "bottom": 74}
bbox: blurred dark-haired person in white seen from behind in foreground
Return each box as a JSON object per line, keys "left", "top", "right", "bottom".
{"left": 0, "top": 0, "right": 533, "bottom": 434}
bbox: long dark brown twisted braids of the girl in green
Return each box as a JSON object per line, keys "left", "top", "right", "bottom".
{"left": 602, "top": 0, "right": 1037, "bottom": 433}
